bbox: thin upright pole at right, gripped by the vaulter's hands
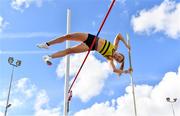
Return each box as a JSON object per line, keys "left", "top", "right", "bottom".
{"left": 126, "top": 33, "right": 137, "bottom": 116}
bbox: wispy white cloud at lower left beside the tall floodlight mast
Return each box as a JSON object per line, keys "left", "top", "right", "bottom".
{"left": 0, "top": 78, "right": 61, "bottom": 116}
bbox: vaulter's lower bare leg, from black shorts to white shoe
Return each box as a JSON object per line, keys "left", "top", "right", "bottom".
{"left": 50, "top": 43, "right": 89, "bottom": 58}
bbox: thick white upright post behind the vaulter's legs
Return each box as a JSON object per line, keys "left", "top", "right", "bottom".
{"left": 64, "top": 9, "right": 71, "bottom": 116}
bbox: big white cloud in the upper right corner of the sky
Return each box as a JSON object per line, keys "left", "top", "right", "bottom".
{"left": 131, "top": 0, "right": 180, "bottom": 38}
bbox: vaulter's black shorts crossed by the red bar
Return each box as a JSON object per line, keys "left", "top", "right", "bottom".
{"left": 84, "top": 34, "right": 99, "bottom": 50}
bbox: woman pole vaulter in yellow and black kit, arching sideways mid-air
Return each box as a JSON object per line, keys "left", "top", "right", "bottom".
{"left": 37, "top": 32, "right": 132, "bottom": 75}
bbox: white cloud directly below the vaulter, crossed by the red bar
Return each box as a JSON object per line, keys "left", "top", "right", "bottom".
{"left": 57, "top": 53, "right": 112, "bottom": 102}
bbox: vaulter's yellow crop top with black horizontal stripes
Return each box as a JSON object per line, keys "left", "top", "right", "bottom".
{"left": 99, "top": 40, "right": 115, "bottom": 59}
